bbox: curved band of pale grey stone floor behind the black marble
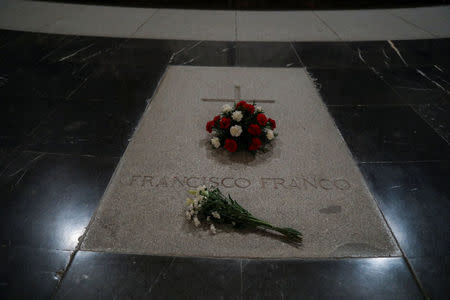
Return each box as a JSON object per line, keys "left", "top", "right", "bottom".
{"left": 0, "top": 0, "right": 450, "bottom": 42}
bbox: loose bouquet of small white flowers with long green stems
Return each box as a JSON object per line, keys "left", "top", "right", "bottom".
{"left": 186, "top": 186, "right": 302, "bottom": 243}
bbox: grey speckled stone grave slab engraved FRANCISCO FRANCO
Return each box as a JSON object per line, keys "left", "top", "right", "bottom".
{"left": 82, "top": 66, "right": 400, "bottom": 258}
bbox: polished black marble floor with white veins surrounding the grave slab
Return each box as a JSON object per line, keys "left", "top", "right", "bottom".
{"left": 0, "top": 31, "right": 450, "bottom": 299}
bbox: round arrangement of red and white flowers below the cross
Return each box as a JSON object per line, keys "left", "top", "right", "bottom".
{"left": 206, "top": 101, "right": 277, "bottom": 153}
